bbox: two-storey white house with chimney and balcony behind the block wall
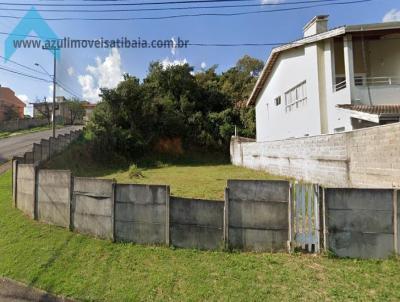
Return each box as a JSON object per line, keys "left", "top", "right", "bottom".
{"left": 247, "top": 16, "right": 400, "bottom": 142}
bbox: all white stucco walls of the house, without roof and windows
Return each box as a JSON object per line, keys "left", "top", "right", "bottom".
{"left": 256, "top": 35, "right": 400, "bottom": 142}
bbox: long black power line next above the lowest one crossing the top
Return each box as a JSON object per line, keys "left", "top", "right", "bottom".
{"left": 0, "top": 0, "right": 341, "bottom": 13}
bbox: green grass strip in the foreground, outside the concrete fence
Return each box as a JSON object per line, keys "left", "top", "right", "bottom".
{"left": 0, "top": 172, "right": 400, "bottom": 301}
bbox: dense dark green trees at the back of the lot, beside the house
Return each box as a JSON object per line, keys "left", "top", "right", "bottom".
{"left": 88, "top": 56, "right": 263, "bottom": 157}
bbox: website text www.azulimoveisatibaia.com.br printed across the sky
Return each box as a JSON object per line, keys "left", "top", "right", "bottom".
{"left": 13, "top": 37, "right": 189, "bottom": 49}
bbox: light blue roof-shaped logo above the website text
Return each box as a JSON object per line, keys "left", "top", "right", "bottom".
{"left": 4, "top": 6, "right": 60, "bottom": 62}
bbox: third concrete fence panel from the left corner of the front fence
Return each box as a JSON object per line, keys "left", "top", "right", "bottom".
{"left": 71, "top": 177, "right": 114, "bottom": 240}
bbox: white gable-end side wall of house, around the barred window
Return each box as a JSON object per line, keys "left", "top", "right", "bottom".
{"left": 256, "top": 45, "right": 321, "bottom": 142}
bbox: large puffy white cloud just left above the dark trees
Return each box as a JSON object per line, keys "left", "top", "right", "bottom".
{"left": 78, "top": 48, "right": 123, "bottom": 101}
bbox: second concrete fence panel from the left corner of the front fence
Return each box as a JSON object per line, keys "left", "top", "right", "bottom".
{"left": 37, "top": 170, "right": 71, "bottom": 228}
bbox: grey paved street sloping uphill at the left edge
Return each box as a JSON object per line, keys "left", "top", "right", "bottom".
{"left": 0, "top": 126, "right": 82, "bottom": 164}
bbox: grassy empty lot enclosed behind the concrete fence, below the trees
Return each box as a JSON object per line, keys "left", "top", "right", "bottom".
{"left": 48, "top": 144, "right": 278, "bottom": 200}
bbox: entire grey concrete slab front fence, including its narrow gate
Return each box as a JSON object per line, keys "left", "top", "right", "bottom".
{"left": 9, "top": 138, "right": 400, "bottom": 258}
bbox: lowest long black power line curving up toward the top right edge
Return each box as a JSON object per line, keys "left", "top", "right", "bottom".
{"left": 0, "top": 0, "right": 373, "bottom": 21}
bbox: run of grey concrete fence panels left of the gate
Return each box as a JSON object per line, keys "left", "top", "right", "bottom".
{"left": 13, "top": 165, "right": 290, "bottom": 252}
